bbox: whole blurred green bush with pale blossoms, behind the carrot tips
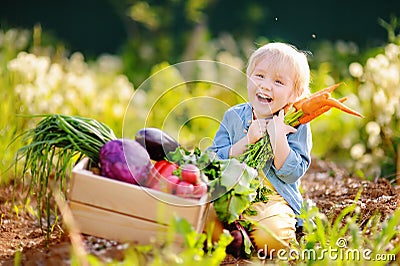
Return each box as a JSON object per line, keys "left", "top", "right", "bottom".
{"left": 311, "top": 19, "right": 400, "bottom": 180}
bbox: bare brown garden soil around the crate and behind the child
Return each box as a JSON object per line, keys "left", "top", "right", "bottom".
{"left": 0, "top": 160, "right": 400, "bottom": 265}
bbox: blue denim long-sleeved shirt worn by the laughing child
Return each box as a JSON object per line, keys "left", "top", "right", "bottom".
{"left": 210, "top": 103, "right": 312, "bottom": 225}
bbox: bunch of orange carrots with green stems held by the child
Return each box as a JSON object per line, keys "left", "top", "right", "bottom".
{"left": 239, "top": 83, "right": 363, "bottom": 170}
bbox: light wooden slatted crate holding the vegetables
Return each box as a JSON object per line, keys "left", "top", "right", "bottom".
{"left": 68, "top": 158, "right": 209, "bottom": 244}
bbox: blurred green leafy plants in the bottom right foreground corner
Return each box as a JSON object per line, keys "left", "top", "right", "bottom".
{"left": 288, "top": 196, "right": 400, "bottom": 265}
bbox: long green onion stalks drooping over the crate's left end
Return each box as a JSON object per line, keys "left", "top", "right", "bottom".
{"left": 15, "top": 114, "right": 116, "bottom": 236}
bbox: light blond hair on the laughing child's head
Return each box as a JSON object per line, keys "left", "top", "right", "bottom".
{"left": 246, "top": 42, "right": 310, "bottom": 98}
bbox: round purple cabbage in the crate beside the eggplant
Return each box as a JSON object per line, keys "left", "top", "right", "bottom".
{"left": 100, "top": 139, "right": 152, "bottom": 185}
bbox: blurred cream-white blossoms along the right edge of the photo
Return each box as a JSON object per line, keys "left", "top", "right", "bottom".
{"left": 350, "top": 38, "right": 400, "bottom": 182}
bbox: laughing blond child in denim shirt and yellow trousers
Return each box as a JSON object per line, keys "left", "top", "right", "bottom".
{"left": 207, "top": 43, "right": 312, "bottom": 255}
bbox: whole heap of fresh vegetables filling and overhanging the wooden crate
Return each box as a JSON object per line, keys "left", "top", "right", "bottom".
{"left": 16, "top": 114, "right": 257, "bottom": 247}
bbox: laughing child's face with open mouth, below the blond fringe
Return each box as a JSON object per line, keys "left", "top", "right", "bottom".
{"left": 247, "top": 56, "right": 295, "bottom": 118}
